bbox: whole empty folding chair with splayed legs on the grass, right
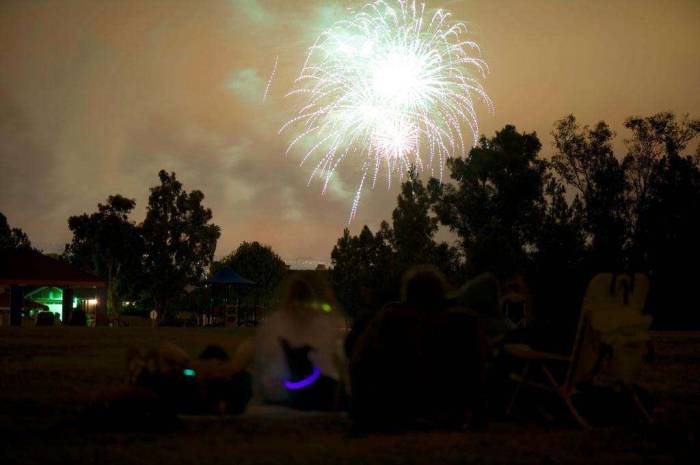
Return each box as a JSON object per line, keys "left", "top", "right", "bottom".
{"left": 505, "top": 273, "right": 650, "bottom": 428}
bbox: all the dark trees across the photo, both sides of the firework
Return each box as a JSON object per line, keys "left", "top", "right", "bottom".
{"left": 0, "top": 113, "right": 700, "bottom": 329}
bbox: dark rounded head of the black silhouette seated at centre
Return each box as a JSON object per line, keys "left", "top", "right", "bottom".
{"left": 401, "top": 265, "right": 447, "bottom": 308}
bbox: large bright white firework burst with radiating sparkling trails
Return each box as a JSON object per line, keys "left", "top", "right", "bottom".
{"left": 280, "top": 0, "right": 492, "bottom": 220}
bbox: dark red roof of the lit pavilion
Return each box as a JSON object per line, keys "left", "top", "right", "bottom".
{"left": 0, "top": 250, "right": 105, "bottom": 287}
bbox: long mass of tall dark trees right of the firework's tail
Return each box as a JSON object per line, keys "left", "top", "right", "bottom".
{"left": 331, "top": 113, "right": 700, "bottom": 329}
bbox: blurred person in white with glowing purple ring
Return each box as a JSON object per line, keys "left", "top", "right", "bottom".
{"left": 255, "top": 276, "right": 345, "bottom": 410}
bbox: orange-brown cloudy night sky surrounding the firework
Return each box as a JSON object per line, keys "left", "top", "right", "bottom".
{"left": 0, "top": 0, "right": 700, "bottom": 262}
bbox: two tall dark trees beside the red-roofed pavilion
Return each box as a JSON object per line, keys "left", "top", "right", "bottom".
{"left": 63, "top": 171, "right": 220, "bottom": 317}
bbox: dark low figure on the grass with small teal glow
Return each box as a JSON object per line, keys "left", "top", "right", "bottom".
{"left": 82, "top": 342, "right": 252, "bottom": 431}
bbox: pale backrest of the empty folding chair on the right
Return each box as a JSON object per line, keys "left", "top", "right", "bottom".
{"left": 566, "top": 273, "right": 651, "bottom": 388}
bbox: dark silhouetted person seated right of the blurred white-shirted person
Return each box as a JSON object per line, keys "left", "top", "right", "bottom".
{"left": 350, "top": 266, "right": 487, "bottom": 430}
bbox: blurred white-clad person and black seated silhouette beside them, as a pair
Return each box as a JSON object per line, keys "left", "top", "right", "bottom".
{"left": 254, "top": 266, "right": 490, "bottom": 431}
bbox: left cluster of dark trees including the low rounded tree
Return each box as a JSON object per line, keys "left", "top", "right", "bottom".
{"left": 57, "top": 171, "right": 287, "bottom": 319}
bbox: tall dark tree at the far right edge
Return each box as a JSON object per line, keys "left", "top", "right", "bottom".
{"left": 625, "top": 113, "right": 700, "bottom": 329}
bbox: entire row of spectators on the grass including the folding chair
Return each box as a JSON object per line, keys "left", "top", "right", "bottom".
{"left": 117, "top": 265, "right": 650, "bottom": 433}
